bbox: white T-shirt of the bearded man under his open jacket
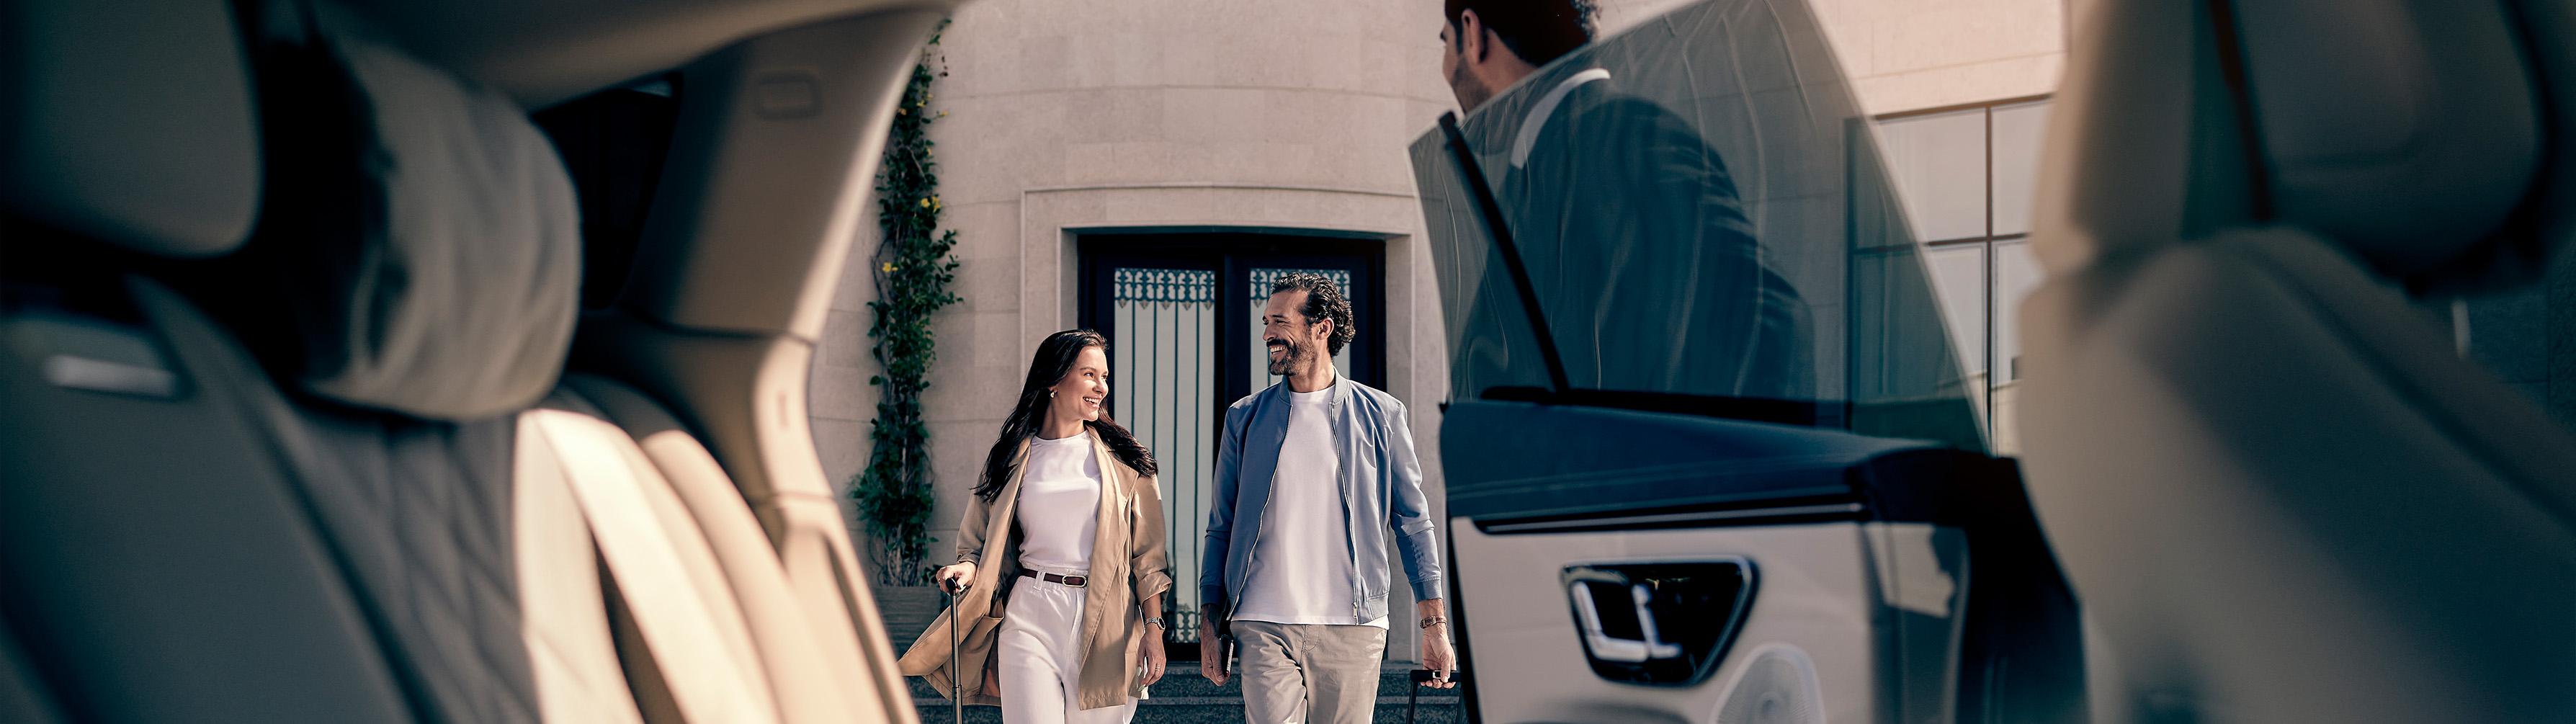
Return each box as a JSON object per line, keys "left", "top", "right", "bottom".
{"left": 1234, "top": 386, "right": 1386, "bottom": 629}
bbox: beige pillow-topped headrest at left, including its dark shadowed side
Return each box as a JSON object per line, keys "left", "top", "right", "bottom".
{"left": 196, "top": 3, "right": 582, "bottom": 420}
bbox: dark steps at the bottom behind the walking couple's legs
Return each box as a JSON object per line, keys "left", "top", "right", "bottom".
{"left": 904, "top": 662, "right": 1466, "bottom": 724}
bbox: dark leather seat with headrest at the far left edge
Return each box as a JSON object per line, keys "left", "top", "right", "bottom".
{"left": 0, "top": 0, "right": 412, "bottom": 721}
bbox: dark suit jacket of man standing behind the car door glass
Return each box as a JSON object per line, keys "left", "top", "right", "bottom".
{"left": 1468, "top": 77, "right": 1816, "bottom": 399}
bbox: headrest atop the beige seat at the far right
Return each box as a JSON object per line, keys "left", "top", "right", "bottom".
{"left": 2236, "top": 0, "right": 2545, "bottom": 287}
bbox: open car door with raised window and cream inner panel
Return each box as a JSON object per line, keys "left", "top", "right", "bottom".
{"left": 1412, "top": 0, "right": 2084, "bottom": 721}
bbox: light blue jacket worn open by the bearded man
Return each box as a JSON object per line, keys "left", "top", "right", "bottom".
{"left": 1198, "top": 379, "right": 1443, "bottom": 629}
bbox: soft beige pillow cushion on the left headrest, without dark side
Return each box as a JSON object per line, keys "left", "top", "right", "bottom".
{"left": 301, "top": 5, "right": 582, "bottom": 420}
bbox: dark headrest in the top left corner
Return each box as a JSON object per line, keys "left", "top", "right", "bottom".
{"left": 0, "top": 0, "right": 260, "bottom": 258}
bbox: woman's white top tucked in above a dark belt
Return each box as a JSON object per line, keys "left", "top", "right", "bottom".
{"left": 1015, "top": 430, "right": 1100, "bottom": 572}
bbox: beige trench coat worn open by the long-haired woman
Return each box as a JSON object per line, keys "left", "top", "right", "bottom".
{"left": 899, "top": 435, "right": 1172, "bottom": 709}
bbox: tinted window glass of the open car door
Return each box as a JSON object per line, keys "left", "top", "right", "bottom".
{"left": 1412, "top": 0, "right": 1986, "bottom": 451}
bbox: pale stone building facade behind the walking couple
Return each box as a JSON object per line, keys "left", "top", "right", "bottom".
{"left": 811, "top": 0, "right": 2066, "bottom": 660}
